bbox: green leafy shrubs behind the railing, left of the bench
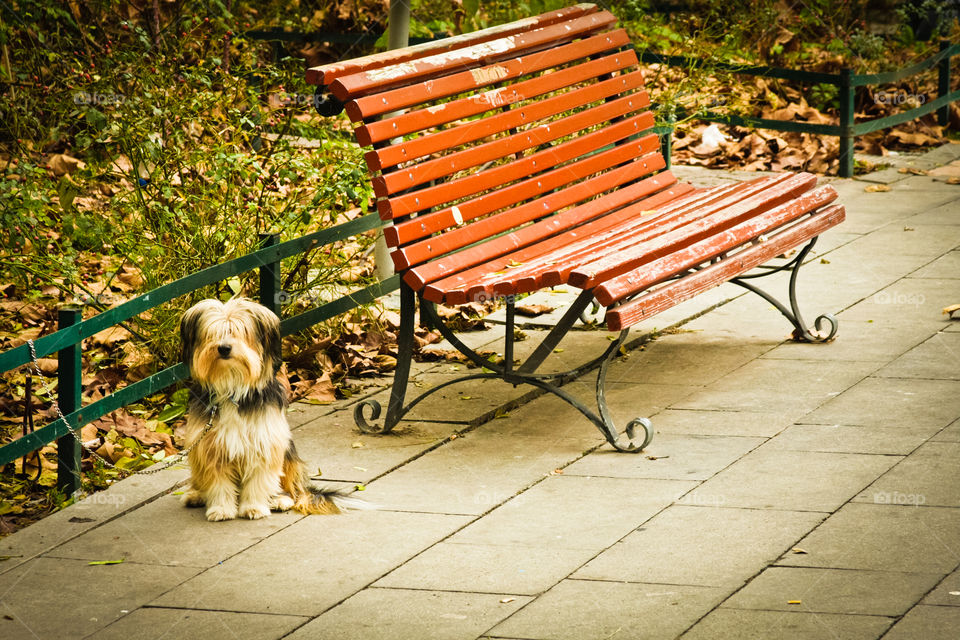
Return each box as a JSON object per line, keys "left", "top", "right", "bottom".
{"left": 0, "top": 0, "right": 372, "bottom": 368}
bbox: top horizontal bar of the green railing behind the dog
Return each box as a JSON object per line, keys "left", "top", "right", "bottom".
{"left": 0, "top": 213, "right": 382, "bottom": 373}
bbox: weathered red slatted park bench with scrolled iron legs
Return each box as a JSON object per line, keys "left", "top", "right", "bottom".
{"left": 307, "top": 4, "right": 844, "bottom": 452}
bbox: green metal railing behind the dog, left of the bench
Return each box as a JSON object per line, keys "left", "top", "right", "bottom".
{"left": 0, "top": 213, "right": 400, "bottom": 494}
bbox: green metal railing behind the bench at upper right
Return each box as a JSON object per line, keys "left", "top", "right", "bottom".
{"left": 634, "top": 40, "right": 960, "bottom": 178}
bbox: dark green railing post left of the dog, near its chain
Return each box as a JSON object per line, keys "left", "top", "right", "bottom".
{"left": 57, "top": 307, "right": 83, "bottom": 497}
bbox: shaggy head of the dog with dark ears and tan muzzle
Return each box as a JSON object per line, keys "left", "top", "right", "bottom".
{"left": 180, "top": 298, "right": 282, "bottom": 398}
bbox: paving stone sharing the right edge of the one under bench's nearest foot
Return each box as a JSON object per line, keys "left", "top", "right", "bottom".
{"left": 686, "top": 447, "right": 899, "bottom": 511}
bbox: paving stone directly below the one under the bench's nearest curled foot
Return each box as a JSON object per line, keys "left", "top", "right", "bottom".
{"left": 447, "top": 476, "right": 696, "bottom": 551}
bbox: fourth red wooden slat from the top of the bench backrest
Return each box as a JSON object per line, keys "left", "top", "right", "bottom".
{"left": 353, "top": 49, "right": 637, "bottom": 147}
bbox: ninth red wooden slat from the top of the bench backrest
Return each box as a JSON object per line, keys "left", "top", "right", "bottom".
{"left": 390, "top": 153, "right": 665, "bottom": 271}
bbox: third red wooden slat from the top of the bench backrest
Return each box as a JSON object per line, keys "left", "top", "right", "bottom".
{"left": 345, "top": 29, "right": 630, "bottom": 122}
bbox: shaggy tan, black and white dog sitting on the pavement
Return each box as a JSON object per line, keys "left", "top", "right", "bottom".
{"left": 180, "top": 298, "right": 365, "bottom": 521}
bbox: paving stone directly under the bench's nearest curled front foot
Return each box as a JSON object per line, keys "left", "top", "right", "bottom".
{"left": 564, "top": 432, "right": 764, "bottom": 480}
